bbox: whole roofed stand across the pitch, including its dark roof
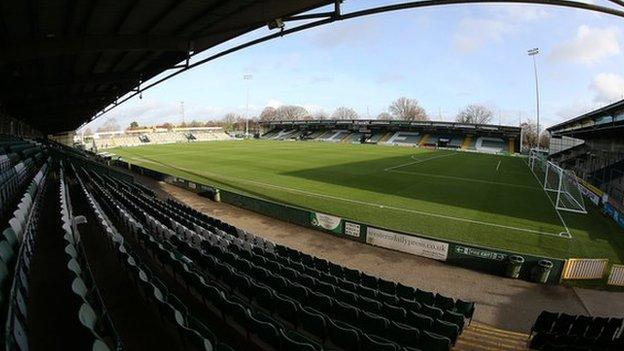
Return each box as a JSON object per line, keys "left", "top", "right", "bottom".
{"left": 260, "top": 120, "right": 521, "bottom": 153}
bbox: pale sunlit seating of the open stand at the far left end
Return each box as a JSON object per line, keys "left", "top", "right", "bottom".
{"left": 93, "top": 130, "right": 231, "bottom": 150}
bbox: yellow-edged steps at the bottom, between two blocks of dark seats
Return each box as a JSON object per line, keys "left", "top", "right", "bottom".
{"left": 453, "top": 322, "right": 529, "bottom": 351}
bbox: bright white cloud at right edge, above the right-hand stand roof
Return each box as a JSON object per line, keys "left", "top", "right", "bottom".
{"left": 549, "top": 25, "right": 621, "bottom": 65}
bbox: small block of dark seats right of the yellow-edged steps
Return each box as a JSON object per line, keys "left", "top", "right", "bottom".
{"left": 530, "top": 311, "right": 624, "bottom": 351}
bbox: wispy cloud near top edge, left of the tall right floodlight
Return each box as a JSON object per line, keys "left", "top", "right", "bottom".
{"left": 454, "top": 4, "right": 550, "bottom": 53}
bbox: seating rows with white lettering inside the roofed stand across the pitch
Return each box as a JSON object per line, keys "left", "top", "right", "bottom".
{"left": 261, "top": 129, "right": 513, "bottom": 153}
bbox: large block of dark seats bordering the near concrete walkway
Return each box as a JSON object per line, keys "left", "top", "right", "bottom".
{"left": 67, "top": 153, "right": 474, "bottom": 350}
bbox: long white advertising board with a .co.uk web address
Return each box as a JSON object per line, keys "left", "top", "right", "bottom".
{"left": 366, "top": 227, "right": 449, "bottom": 261}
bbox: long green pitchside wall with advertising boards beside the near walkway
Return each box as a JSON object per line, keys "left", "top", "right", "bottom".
{"left": 113, "top": 161, "right": 565, "bottom": 284}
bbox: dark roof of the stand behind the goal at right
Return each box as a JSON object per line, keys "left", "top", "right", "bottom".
{"left": 547, "top": 100, "right": 624, "bottom": 138}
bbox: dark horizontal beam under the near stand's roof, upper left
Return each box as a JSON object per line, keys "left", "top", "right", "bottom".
{"left": 0, "top": 34, "right": 192, "bottom": 63}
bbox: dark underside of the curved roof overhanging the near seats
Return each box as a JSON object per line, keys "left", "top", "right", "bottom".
{"left": 0, "top": 0, "right": 333, "bottom": 133}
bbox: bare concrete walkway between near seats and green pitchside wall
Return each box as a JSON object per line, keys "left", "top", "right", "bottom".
{"left": 133, "top": 174, "right": 624, "bottom": 338}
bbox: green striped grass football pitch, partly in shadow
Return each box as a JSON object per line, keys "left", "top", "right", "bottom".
{"left": 109, "top": 141, "right": 624, "bottom": 262}
